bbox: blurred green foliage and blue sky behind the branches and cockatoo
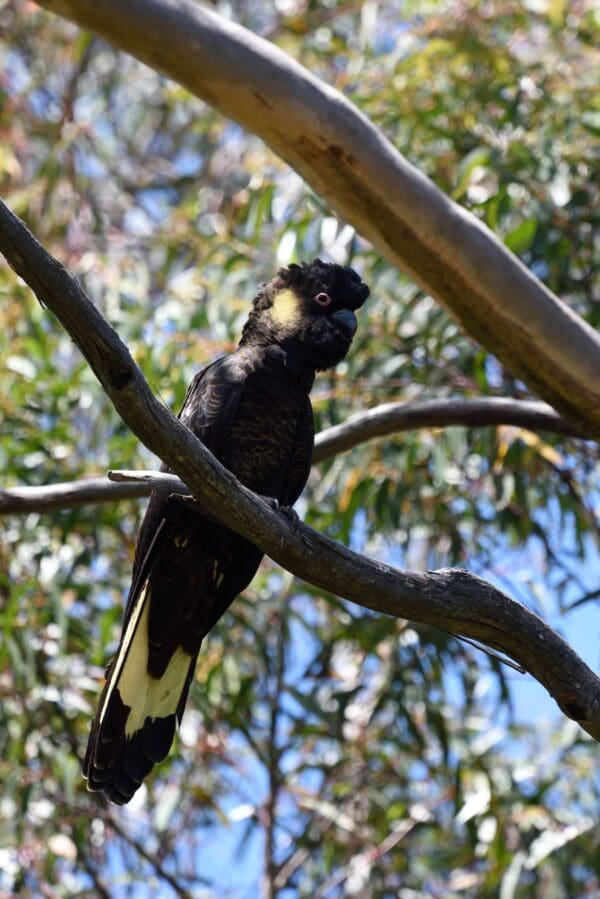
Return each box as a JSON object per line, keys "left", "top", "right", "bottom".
{"left": 0, "top": 0, "right": 600, "bottom": 899}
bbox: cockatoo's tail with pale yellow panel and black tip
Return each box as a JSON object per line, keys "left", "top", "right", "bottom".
{"left": 83, "top": 578, "right": 197, "bottom": 805}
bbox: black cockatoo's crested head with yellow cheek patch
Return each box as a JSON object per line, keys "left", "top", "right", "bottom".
{"left": 240, "top": 259, "right": 369, "bottom": 371}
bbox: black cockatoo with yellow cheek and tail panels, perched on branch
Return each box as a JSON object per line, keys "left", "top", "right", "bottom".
{"left": 83, "top": 259, "right": 369, "bottom": 805}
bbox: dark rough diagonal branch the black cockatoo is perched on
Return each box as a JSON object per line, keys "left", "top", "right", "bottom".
{"left": 0, "top": 202, "right": 600, "bottom": 741}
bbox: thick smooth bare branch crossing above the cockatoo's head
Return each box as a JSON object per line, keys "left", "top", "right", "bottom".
{"left": 38, "top": 0, "right": 600, "bottom": 437}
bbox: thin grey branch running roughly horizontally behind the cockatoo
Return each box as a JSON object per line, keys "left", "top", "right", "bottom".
{"left": 0, "top": 397, "right": 583, "bottom": 517}
